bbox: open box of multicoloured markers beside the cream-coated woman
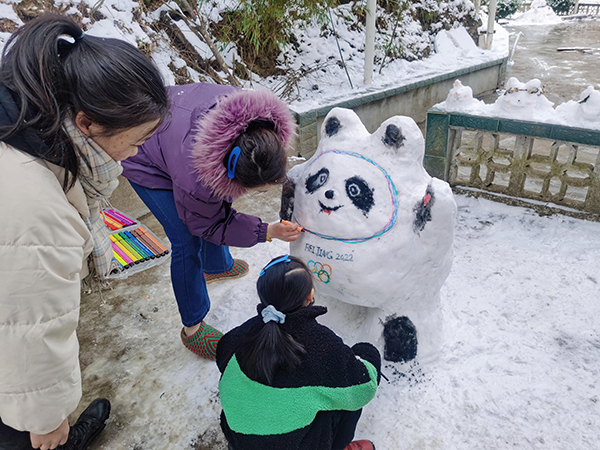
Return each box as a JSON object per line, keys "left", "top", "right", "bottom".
{"left": 101, "top": 208, "right": 171, "bottom": 279}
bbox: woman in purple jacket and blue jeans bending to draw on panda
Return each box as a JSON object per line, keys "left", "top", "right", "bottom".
{"left": 123, "top": 83, "right": 299, "bottom": 360}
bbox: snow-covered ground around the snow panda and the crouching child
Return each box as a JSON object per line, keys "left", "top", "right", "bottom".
{"left": 74, "top": 185, "right": 600, "bottom": 450}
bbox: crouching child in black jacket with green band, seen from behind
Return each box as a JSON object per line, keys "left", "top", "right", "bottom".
{"left": 217, "top": 255, "right": 381, "bottom": 450}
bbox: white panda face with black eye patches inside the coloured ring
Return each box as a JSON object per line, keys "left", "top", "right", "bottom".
{"left": 294, "top": 150, "right": 397, "bottom": 239}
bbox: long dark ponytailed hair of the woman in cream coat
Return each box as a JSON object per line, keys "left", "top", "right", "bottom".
{"left": 0, "top": 14, "right": 169, "bottom": 188}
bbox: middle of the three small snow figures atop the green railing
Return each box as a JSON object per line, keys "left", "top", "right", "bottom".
{"left": 494, "top": 77, "right": 554, "bottom": 121}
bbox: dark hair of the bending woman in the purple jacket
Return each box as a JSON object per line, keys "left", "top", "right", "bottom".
{"left": 223, "top": 120, "right": 287, "bottom": 189}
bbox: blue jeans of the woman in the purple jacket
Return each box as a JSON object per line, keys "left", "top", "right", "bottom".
{"left": 130, "top": 182, "right": 234, "bottom": 327}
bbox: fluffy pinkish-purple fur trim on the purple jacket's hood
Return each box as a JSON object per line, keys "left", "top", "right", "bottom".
{"left": 192, "top": 90, "right": 296, "bottom": 200}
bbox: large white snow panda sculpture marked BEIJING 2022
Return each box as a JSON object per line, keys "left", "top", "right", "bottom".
{"left": 280, "top": 108, "right": 456, "bottom": 361}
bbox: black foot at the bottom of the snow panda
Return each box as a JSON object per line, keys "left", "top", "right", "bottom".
{"left": 383, "top": 316, "right": 417, "bottom": 362}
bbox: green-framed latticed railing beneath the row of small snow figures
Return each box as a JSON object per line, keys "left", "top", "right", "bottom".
{"left": 424, "top": 109, "right": 600, "bottom": 214}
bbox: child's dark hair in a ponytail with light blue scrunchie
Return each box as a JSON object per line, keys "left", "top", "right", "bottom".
{"left": 236, "top": 256, "right": 313, "bottom": 384}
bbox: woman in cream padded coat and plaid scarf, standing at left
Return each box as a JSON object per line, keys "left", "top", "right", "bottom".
{"left": 0, "top": 15, "right": 168, "bottom": 450}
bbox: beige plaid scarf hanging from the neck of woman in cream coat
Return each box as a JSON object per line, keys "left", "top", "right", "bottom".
{"left": 64, "top": 119, "right": 123, "bottom": 278}
